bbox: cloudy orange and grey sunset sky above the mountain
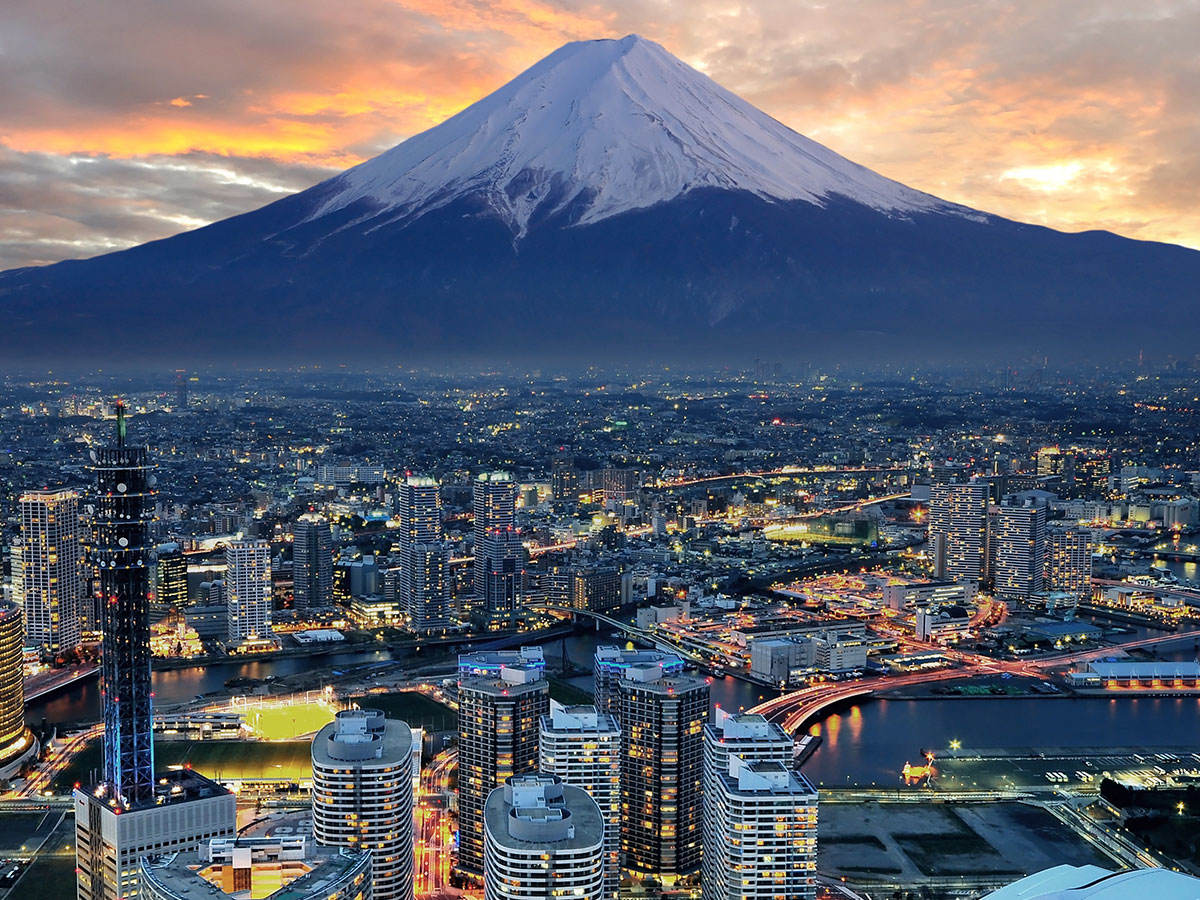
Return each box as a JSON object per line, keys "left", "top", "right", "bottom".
{"left": 0, "top": 0, "right": 1200, "bottom": 269}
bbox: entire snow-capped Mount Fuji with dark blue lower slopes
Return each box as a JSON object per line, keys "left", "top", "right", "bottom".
{"left": 0, "top": 36, "right": 1200, "bottom": 362}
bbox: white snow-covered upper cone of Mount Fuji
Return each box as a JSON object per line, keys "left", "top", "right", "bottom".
{"left": 308, "top": 35, "right": 978, "bottom": 235}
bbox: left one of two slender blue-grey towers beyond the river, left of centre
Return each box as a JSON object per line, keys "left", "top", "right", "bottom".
{"left": 397, "top": 475, "right": 451, "bottom": 632}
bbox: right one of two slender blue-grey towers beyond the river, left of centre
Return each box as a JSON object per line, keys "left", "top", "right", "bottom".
{"left": 473, "top": 472, "right": 524, "bottom": 628}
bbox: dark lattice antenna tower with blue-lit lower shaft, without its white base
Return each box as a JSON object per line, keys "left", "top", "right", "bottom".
{"left": 92, "top": 403, "right": 155, "bottom": 809}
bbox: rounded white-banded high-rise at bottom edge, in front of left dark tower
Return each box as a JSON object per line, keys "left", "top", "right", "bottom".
{"left": 484, "top": 774, "right": 605, "bottom": 900}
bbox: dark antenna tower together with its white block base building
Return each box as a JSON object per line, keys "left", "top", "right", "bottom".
{"left": 74, "top": 402, "right": 236, "bottom": 900}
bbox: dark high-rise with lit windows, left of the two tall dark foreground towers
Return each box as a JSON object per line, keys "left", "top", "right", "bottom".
{"left": 458, "top": 647, "right": 550, "bottom": 875}
